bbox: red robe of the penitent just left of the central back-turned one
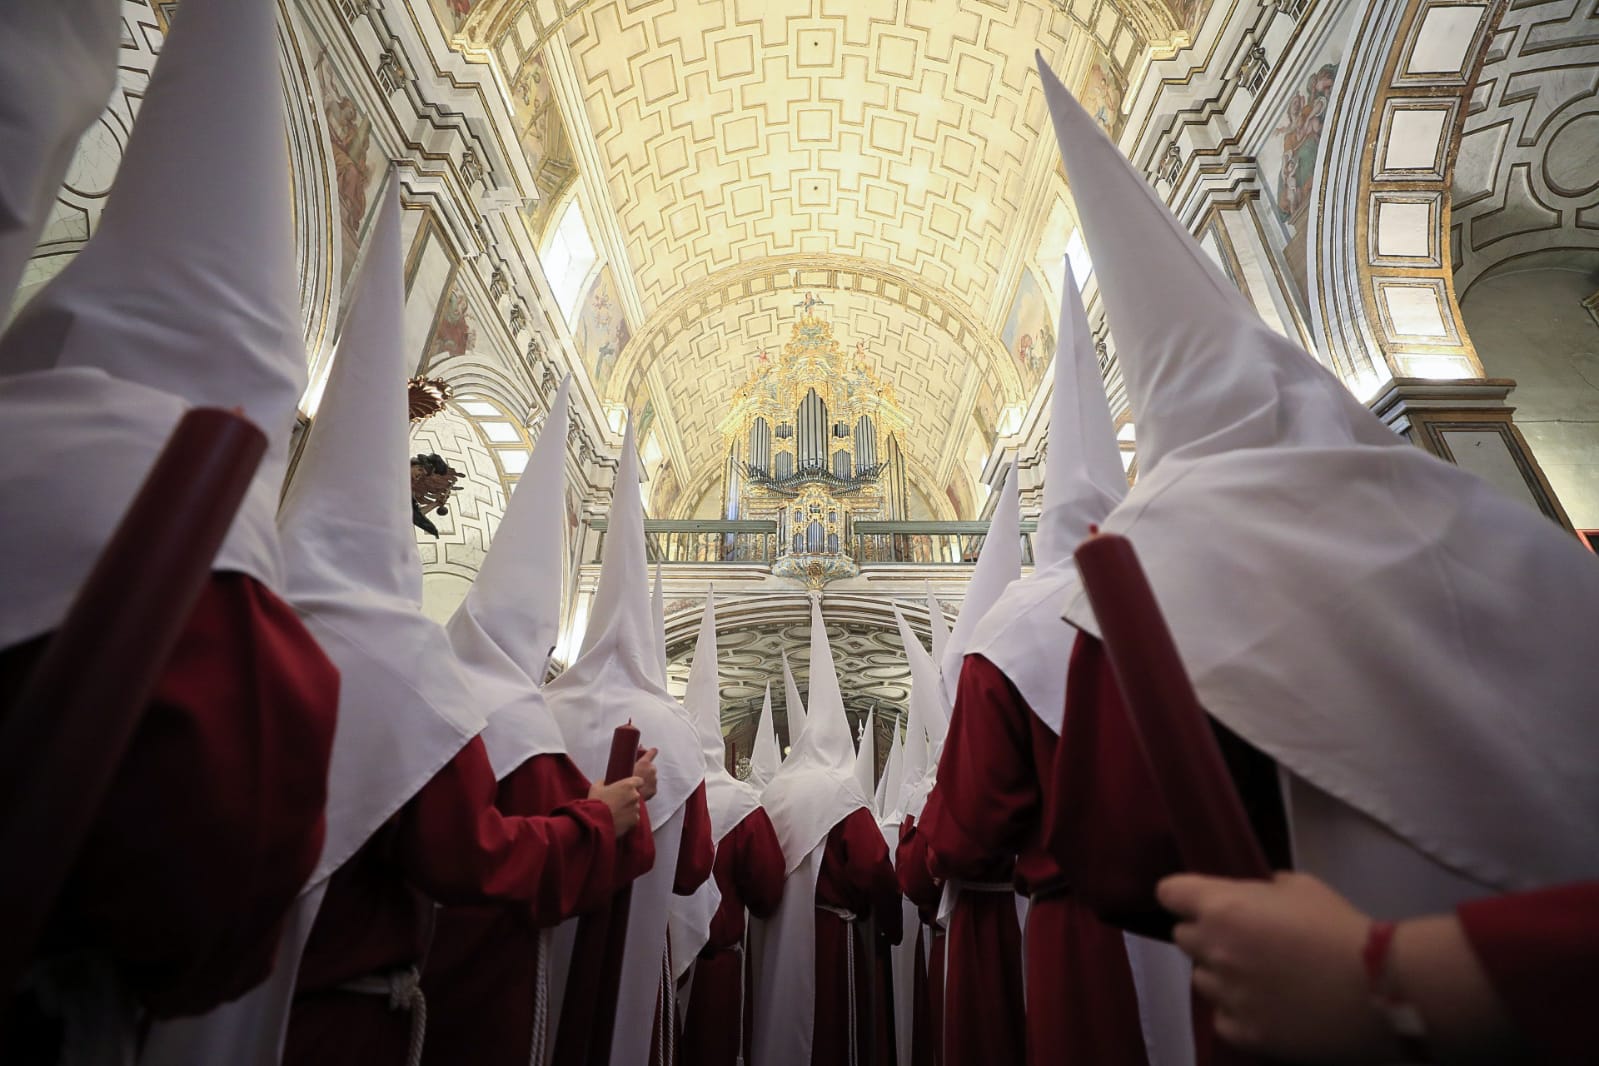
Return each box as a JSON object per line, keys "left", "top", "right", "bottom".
{"left": 680, "top": 807, "right": 784, "bottom": 1066}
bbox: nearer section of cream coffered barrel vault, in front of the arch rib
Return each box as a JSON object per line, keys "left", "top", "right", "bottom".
{"left": 566, "top": 0, "right": 1116, "bottom": 315}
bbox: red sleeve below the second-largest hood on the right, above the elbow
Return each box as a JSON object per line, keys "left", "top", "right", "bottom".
{"left": 921, "top": 655, "right": 1043, "bottom": 881}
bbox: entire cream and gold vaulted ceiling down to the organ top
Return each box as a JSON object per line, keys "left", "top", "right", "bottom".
{"left": 432, "top": 0, "right": 1194, "bottom": 516}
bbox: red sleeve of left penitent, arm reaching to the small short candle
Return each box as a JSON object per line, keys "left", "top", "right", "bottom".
{"left": 398, "top": 737, "right": 616, "bottom": 922}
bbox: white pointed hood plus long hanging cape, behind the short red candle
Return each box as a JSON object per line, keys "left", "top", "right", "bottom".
{"left": 544, "top": 424, "right": 705, "bottom": 1066}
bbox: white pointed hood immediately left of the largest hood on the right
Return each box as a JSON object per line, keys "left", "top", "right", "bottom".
{"left": 961, "top": 254, "right": 1127, "bottom": 732}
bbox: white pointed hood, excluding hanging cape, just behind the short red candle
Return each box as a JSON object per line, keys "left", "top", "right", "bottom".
{"left": 545, "top": 424, "right": 705, "bottom": 825}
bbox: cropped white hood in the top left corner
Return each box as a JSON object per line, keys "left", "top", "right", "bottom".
{"left": 0, "top": 0, "right": 122, "bottom": 313}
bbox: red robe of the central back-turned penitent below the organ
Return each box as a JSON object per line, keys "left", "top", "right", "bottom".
{"left": 811, "top": 807, "right": 900, "bottom": 1066}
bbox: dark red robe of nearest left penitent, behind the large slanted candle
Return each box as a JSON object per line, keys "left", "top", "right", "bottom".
{"left": 0, "top": 574, "right": 339, "bottom": 1061}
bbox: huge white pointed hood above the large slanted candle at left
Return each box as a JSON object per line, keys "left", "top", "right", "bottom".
{"left": 0, "top": 0, "right": 305, "bottom": 647}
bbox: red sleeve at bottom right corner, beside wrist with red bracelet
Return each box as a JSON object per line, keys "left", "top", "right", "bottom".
{"left": 1455, "top": 881, "right": 1599, "bottom": 1066}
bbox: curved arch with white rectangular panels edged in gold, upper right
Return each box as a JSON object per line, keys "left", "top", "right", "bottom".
{"left": 1308, "top": 0, "right": 1506, "bottom": 388}
